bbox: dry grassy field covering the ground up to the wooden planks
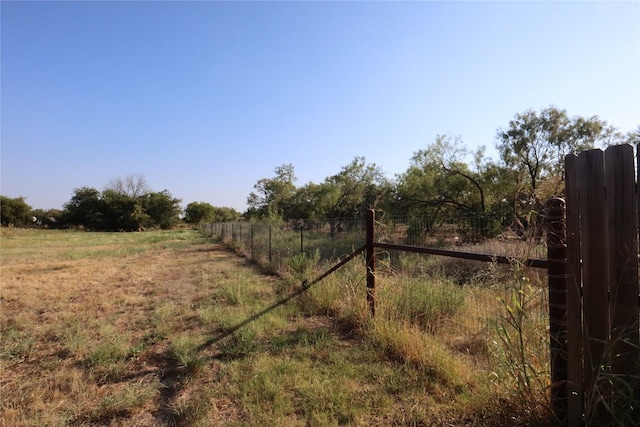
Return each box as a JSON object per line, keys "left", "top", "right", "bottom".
{"left": 0, "top": 228, "right": 551, "bottom": 426}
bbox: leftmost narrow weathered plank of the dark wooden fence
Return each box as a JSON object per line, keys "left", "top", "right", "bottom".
{"left": 565, "top": 154, "right": 583, "bottom": 427}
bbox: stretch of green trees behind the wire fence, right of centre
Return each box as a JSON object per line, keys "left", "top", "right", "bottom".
{"left": 245, "top": 106, "right": 640, "bottom": 236}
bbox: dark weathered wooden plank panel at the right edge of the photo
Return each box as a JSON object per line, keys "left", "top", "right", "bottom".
{"left": 550, "top": 144, "right": 640, "bottom": 426}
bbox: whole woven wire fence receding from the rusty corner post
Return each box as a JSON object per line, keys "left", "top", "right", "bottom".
{"left": 201, "top": 216, "right": 548, "bottom": 336}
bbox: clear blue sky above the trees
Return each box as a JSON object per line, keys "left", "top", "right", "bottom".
{"left": 0, "top": 1, "right": 640, "bottom": 211}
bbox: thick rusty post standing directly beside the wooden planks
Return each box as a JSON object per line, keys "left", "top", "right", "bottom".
{"left": 546, "top": 197, "right": 568, "bottom": 425}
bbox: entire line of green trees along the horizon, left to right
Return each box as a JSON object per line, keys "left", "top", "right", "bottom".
{"left": 0, "top": 106, "right": 640, "bottom": 231}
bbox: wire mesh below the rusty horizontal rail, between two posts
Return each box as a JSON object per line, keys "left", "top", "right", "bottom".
{"left": 376, "top": 246, "right": 548, "bottom": 335}
